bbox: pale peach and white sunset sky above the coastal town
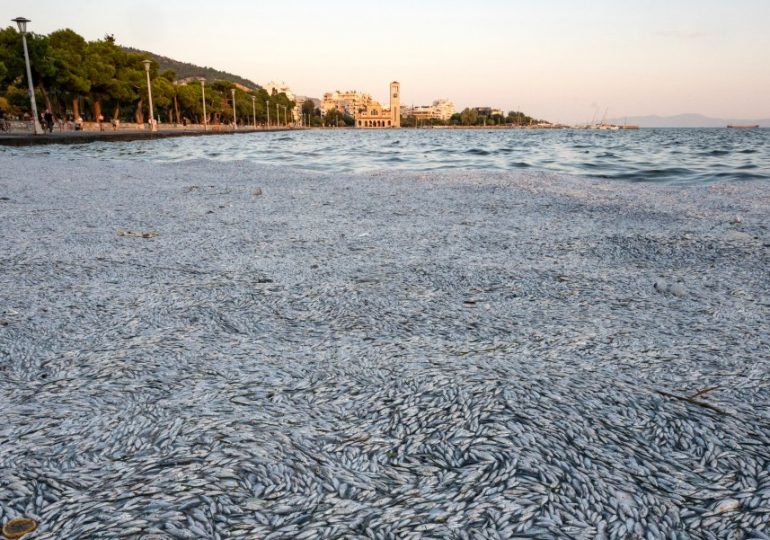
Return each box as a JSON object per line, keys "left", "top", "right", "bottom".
{"left": 6, "top": 0, "right": 770, "bottom": 123}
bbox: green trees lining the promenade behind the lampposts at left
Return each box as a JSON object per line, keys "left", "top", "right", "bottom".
{"left": 0, "top": 26, "right": 294, "bottom": 125}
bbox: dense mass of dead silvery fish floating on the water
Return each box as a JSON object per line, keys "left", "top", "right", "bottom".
{"left": 0, "top": 154, "right": 770, "bottom": 539}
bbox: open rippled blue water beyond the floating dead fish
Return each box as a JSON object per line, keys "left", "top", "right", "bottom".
{"left": 14, "top": 129, "right": 770, "bottom": 183}
